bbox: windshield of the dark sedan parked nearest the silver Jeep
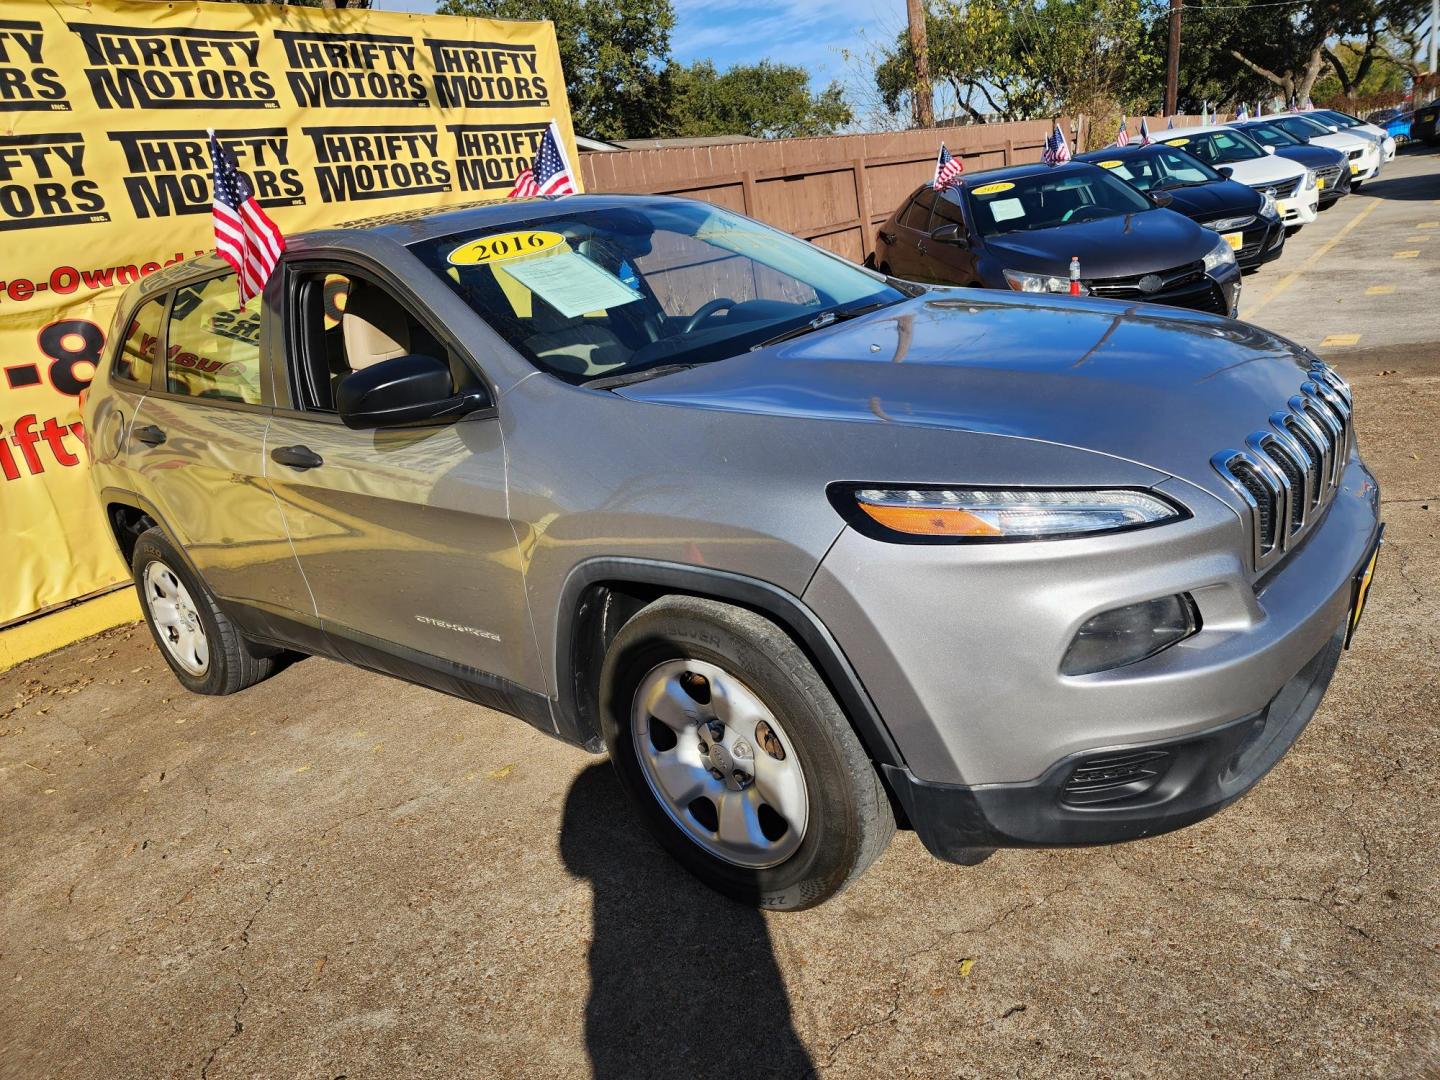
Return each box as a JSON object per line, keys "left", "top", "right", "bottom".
{"left": 965, "top": 166, "right": 1155, "bottom": 236}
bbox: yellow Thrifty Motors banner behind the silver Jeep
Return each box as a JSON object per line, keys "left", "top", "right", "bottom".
{"left": 0, "top": 0, "right": 580, "bottom": 626}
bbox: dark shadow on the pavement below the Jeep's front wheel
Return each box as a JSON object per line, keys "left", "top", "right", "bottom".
{"left": 560, "top": 763, "right": 814, "bottom": 1080}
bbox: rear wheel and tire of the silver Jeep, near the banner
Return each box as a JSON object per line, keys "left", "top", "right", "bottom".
{"left": 130, "top": 527, "right": 276, "bottom": 696}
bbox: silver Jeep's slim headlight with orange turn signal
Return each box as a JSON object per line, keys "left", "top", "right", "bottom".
{"left": 854, "top": 488, "right": 1185, "bottom": 540}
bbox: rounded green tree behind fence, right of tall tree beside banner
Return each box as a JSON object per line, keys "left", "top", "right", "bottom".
{"left": 667, "top": 60, "right": 852, "bottom": 138}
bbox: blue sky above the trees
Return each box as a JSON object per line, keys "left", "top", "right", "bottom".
{"left": 373, "top": 0, "right": 906, "bottom": 100}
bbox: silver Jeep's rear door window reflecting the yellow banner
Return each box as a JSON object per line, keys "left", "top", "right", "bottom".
{"left": 166, "top": 274, "right": 264, "bottom": 405}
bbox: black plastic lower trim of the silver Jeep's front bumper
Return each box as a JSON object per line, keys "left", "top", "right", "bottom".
{"left": 884, "top": 626, "right": 1345, "bottom": 863}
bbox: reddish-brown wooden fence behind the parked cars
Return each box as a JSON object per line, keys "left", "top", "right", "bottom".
{"left": 580, "top": 117, "right": 1200, "bottom": 262}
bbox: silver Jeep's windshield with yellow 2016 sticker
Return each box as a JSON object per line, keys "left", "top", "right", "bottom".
{"left": 410, "top": 202, "right": 906, "bottom": 383}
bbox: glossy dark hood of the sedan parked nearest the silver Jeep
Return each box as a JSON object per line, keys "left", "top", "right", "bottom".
{"left": 985, "top": 209, "right": 1215, "bottom": 279}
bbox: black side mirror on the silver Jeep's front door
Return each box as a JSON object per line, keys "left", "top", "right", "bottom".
{"left": 336, "top": 353, "right": 490, "bottom": 429}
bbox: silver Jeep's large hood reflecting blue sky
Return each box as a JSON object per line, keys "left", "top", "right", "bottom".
{"left": 615, "top": 289, "right": 1310, "bottom": 504}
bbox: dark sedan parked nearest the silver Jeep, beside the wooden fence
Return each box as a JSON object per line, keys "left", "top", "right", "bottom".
{"left": 874, "top": 161, "right": 1240, "bottom": 315}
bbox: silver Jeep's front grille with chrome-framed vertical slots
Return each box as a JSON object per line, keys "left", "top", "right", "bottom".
{"left": 1211, "top": 360, "right": 1354, "bottom": 570}
